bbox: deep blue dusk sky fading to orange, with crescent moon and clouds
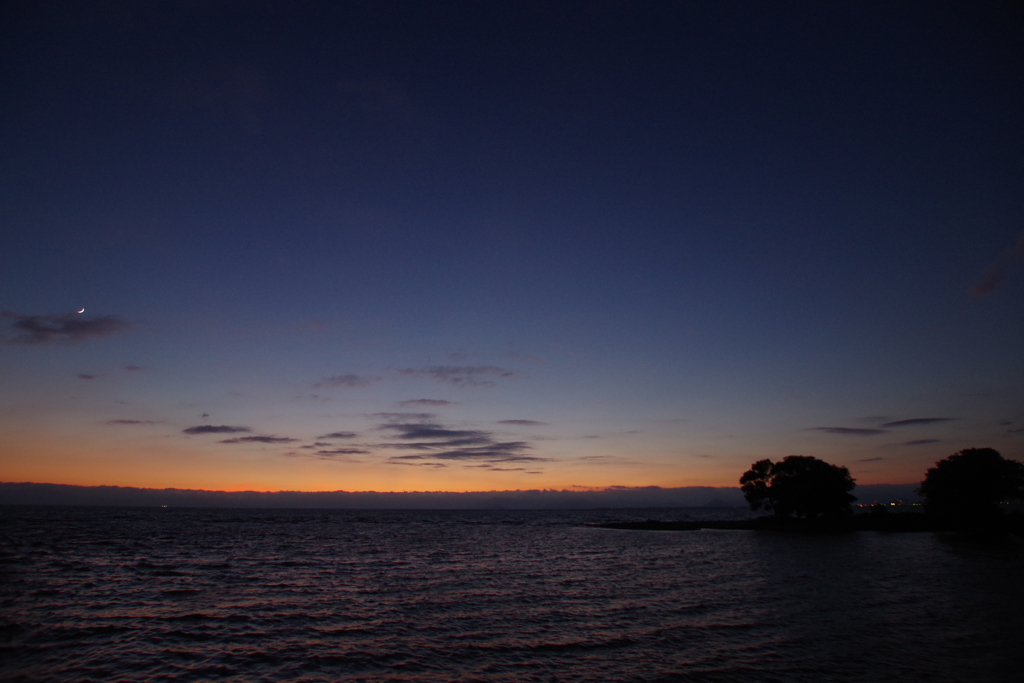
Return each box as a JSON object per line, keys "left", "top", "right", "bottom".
{"left": 0, "top": 0, "right": 1024, "bottom": 492}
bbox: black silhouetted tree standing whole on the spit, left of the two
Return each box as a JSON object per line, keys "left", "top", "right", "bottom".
{"left": 739, "top": 456, "right": 857, "bottom": 519}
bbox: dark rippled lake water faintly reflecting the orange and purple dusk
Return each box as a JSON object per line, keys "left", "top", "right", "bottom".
{"left": 0, "top": 508, "right": 1024, "bottom": 683}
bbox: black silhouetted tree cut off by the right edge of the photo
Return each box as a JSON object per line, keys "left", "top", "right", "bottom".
{"left": 918, "top": 449, "right": 1024, "bottom": 526}
